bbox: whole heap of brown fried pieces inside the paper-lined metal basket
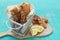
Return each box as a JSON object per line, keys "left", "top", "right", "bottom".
{"left": 11, "top": 3, "right": 30, "bottom": 24}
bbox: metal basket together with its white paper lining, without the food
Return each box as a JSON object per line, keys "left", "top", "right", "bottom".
{"left": 7, "top": 5, "right": 34, "bottom": 36}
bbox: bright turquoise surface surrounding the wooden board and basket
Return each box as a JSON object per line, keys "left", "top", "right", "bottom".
{"left": 0, "top": 0, "right": 60, "bottom": 40}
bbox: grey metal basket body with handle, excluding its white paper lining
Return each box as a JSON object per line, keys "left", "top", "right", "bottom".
{"left": 9, "top": 14, "right": 34, "bottom": 36}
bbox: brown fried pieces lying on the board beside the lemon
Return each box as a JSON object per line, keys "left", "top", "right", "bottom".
{"left": 32, "top": 15, "right": 48, "bottom": 28}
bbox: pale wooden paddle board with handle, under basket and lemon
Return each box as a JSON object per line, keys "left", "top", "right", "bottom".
{"left": 0, "top": 25, "right": 53, "bottom": 38}
